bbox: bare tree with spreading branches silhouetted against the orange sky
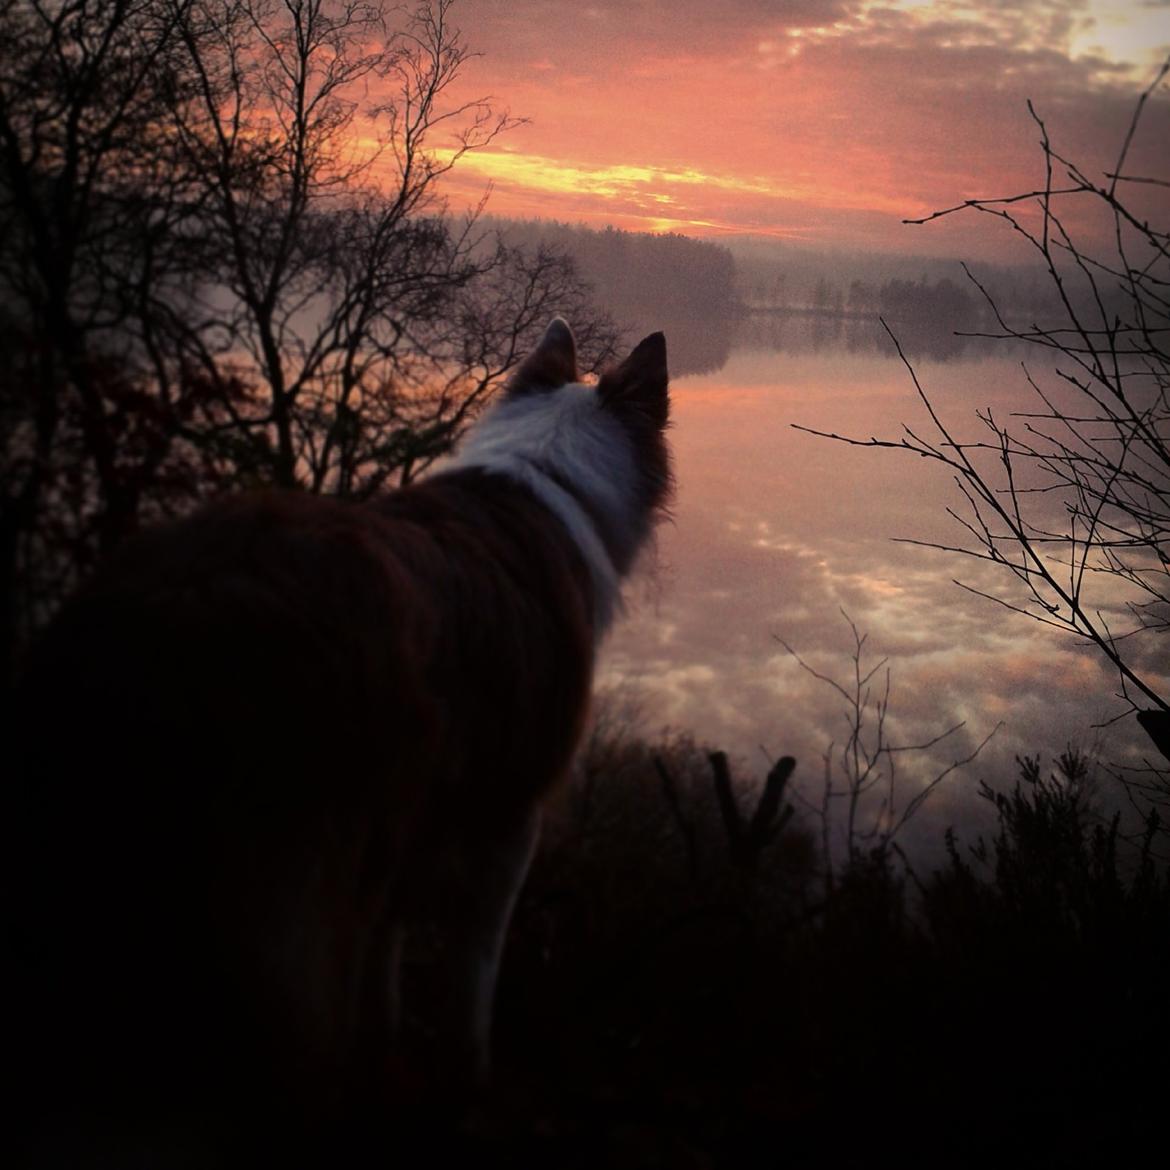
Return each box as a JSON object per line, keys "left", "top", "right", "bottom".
{"left": 159, "top": 0, "right": 510, "bottom": 490}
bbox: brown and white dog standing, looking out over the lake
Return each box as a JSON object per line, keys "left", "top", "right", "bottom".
{"left": 12, "top": 318, "right": 672, "bottom": 1151}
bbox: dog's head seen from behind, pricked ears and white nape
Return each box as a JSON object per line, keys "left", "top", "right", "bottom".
{"left": 456, "top": 317, "right": 672, "bottom": 585}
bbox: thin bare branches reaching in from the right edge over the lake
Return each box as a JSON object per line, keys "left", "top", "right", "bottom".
{"left": 799, "top": 61, "right": 1170, "bottom": 776}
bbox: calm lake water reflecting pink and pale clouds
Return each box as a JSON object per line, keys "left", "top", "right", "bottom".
{"left": 601, "top": 321, "right": 1152, "bottom": 856}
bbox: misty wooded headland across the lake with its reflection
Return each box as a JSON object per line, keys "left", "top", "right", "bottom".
{"left": 494, "top": 220, "right": 742, "bottom": 374}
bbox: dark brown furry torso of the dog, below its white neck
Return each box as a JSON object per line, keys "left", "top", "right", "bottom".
{"left": 14, "top": 472, "right": 593, "bottom": 1123}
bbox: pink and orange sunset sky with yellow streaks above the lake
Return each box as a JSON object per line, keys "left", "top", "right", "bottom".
{"left": 435, "top": 0, "right": 1170, "bottom": 254}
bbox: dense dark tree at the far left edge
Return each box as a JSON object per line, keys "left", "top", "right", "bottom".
{"left": 0, "top": 0, "right": 217, "bottom": 669}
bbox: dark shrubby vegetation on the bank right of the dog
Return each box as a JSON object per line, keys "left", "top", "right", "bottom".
{"left": 442, "top": 736, "right": 1170, "bottom": 1168}
